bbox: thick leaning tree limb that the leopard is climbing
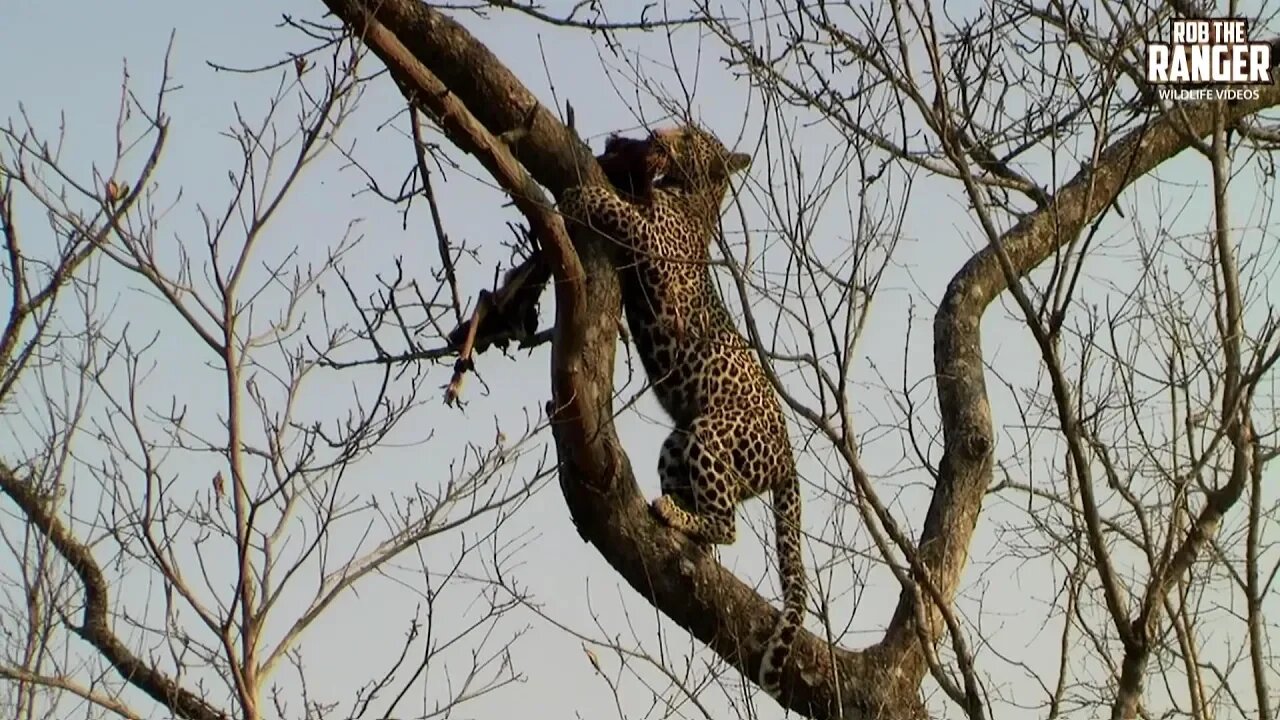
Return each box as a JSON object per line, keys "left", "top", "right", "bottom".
{"left": 314, "top": 0, "right": 919, "bottom": 717}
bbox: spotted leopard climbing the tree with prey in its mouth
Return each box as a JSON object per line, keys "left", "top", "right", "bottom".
{"left": 558, "top": 123, "right": 806, "bottom": 698}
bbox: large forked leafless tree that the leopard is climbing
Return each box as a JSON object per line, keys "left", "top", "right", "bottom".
{"left": 307, "top": 0, "right": 1280, "bottom": 717}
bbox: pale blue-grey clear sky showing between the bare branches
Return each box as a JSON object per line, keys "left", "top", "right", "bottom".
{"left": 0, "top": 0, "right": 1276, "bottom": 717}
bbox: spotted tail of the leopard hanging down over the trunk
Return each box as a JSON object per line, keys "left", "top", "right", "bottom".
{"left": 759, "top": 477, "right": 805, "bottom": 697}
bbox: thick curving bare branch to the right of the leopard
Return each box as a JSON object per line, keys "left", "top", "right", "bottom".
{"left": 911, "top": 85, "right": 1280, "bottom": 638}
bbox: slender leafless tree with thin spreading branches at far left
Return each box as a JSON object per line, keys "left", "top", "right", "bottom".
{"left": 0, "top": 26, "right": 550, "bottom": 720}
